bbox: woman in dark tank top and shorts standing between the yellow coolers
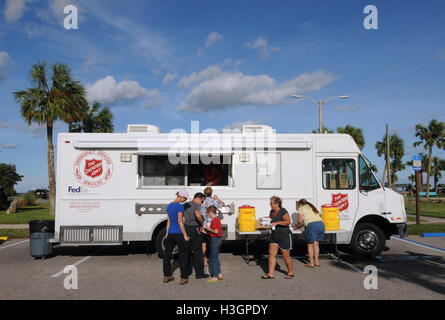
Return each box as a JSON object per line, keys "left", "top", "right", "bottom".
{"left": 261, "top": 196, "right": 294, "bottom": 279}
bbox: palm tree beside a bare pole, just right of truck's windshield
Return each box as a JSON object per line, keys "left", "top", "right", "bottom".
{"left": 375, "top": 133, "right": 405, "bottom": 188}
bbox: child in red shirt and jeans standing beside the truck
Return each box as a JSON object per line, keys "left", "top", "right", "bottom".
{"left": 201, "top": 206, "right": 222, "bottom": 283}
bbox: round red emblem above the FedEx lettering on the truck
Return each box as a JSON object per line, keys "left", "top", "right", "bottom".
{"left": 74, "top": 150, "right": 113, "bottom": 188}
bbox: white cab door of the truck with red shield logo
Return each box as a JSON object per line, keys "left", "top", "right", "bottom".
{"left": 316, "top": 156, "right": 358, "bottom": 230}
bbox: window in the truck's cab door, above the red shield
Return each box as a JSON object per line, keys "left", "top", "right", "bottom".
{"left": 322, "top": 159, "right": 356, "bottom": 190}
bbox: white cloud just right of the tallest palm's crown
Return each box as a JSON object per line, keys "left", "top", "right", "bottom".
{"left": 86, "top": 76, "right": 149, "bottom": 103}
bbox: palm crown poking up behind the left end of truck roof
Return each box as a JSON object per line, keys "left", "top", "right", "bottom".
{"left": 73, "top": 101, "right": 114, "bottom": 133}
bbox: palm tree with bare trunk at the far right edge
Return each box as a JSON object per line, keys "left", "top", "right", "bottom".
{"left": 414, "top": 119, "right": 445, "bottom": 199}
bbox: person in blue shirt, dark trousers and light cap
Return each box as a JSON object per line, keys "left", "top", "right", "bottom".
{"left": 163, "top": 190, "right": 190, "bottom": 285}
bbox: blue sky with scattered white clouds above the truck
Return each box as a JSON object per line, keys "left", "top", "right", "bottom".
{"left": 0, "top": 0, "right": 445, "bottom": 192}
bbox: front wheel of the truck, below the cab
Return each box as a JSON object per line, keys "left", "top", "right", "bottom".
{"left": 351, "top": 223, "right": 386, "bottom": 257}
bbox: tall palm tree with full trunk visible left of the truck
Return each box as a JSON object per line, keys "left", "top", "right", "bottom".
{"left": 14, "top": 62, "right": 83, "bottom": 215}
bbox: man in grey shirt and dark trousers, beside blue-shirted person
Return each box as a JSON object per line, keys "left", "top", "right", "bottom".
{"left": 184, "top": 192, "right": 209, "bottom": 279}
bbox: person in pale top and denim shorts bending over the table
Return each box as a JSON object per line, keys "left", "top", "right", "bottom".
{"left": 295, "top": 199, "right": 325, "bottom": 268}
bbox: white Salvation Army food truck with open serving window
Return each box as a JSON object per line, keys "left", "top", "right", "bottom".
{"left": 52, "top": 125, "right": 406, "bottom": 255}
